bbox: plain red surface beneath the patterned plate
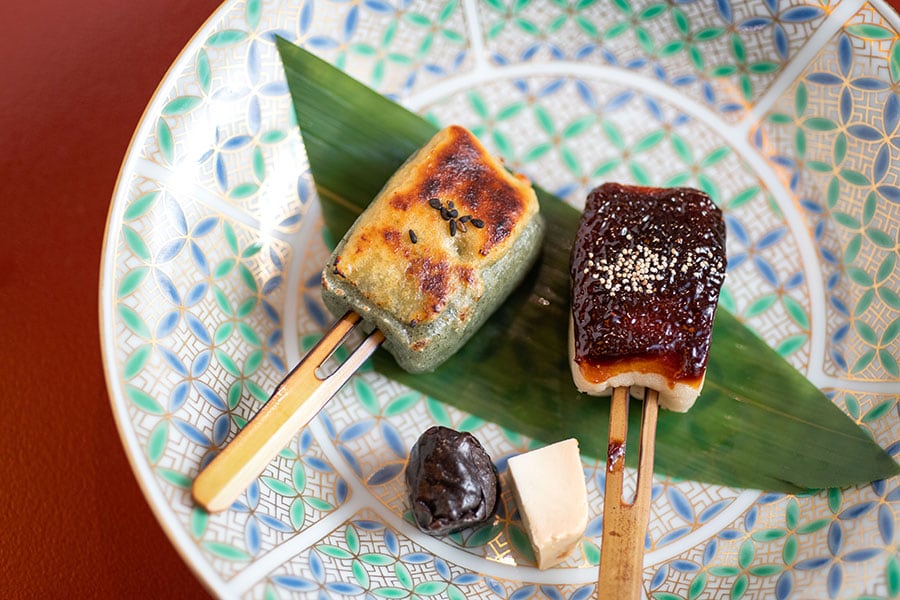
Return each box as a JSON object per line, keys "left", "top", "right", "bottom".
{"left": 0, "top": 0, "right": 900, "bottom": 598}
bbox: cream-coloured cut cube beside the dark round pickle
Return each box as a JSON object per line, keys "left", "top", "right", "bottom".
{"left": 508, "top": 438, "right": 588, "bottom": 569}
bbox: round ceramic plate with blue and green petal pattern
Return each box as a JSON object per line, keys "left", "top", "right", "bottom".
{"left": 100, "top": 0, "right": 900, "bottom": 599}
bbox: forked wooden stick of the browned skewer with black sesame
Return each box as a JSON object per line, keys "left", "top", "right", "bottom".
{"left": 192, "top": 312, "right": 384, "bottom": 512}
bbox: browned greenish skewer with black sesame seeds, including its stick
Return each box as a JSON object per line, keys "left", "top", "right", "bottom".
{"left": 193, "top": 126, "right": 544, "bottom": 511}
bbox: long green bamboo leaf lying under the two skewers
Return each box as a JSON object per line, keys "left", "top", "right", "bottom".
{"left": 278, "top": 39, "right": 900, "bottom": 490}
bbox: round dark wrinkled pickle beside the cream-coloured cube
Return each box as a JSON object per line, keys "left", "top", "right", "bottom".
{"left": 406, "top": 426, "right": 500, "bottom": 535}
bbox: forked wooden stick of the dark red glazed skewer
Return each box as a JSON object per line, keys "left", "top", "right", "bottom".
{"left": 597, "top": 387, "right": 659, "bottom": 600}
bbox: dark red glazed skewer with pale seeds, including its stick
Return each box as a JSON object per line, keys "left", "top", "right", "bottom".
{"left": 569, "top": 183, "right": 726, "bottom": 600}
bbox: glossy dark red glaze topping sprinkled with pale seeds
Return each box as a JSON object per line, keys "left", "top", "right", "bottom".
{"left": 571, "top": 183, "right": 726, "bottom": 385}
